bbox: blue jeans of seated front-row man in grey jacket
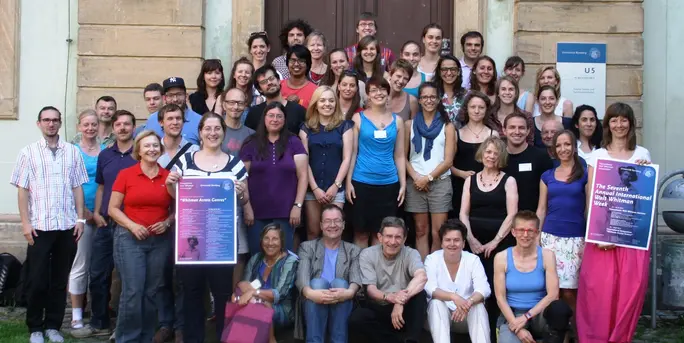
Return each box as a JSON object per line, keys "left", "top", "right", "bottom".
{"left": 304, "top": 278, "right": 353, "bottom": 343}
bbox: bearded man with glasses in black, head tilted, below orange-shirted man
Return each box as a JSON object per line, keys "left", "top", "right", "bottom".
{"left": 245, "top": 65, "right": 306, "bottom": 135}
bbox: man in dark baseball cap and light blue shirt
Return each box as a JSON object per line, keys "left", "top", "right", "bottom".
{"left": 145, "top": 77, "right": 202, "bottom": 145}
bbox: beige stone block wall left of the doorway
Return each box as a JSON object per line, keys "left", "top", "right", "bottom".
{"left": 77, "top": 0, "right": 204, "bottom": 123}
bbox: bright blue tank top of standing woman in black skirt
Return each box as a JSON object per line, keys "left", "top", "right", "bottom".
{"left": 352, "top": 112, "right": 399, "bottom": 186}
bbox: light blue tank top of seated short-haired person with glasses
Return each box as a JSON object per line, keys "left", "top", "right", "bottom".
{"left": 506, "top": 247, "right": 546, "bottom": 310}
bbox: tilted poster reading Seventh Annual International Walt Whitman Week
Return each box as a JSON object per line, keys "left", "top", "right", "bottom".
{"left": 585, "top": 159, "right": 658, "bottom": 250}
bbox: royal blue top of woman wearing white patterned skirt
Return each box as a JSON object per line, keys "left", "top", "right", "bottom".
{"left": 541, "top": 167, "right": 587, "bottom": 237}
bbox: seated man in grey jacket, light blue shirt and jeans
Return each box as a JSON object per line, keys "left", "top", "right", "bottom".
{"left": 295, "top": 204, "right": 361, "bottom": 343}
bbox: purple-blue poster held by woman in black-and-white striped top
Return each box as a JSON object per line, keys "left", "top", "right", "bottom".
{"left": 175, "top": 176, "right": 237, "bottom": 264}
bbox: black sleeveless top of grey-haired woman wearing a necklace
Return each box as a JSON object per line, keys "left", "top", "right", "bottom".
{"left": 470, "top": 174, "right": 509, "bottom": 242}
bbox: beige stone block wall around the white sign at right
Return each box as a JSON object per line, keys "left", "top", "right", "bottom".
{"left": 515, "top": 0, "right": 644, "bottom": 141}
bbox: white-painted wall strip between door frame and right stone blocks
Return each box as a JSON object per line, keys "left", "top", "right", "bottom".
{"left": 484, "top": 0, "right": 515, "bottom": 72}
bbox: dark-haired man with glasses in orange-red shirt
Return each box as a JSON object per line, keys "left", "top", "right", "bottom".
{"left": 280, "top": 44, "right": 316, "bottom": 108}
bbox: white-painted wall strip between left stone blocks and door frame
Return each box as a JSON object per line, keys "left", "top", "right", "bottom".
{"left": 204, "top": 0, "right": 233, "bottom": 63}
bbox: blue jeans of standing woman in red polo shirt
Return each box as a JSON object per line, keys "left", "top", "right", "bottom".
{"left": 114, "top": 225, "right": 171, "bottom": 343}
